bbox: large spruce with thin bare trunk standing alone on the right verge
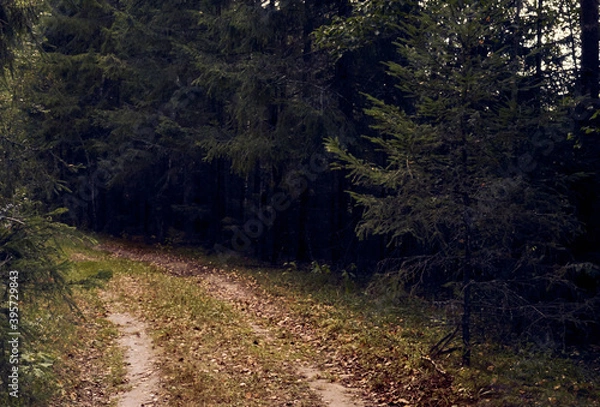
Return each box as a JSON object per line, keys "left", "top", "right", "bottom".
{"left": 328, "top": 0, "right": 581, "bottom": 364}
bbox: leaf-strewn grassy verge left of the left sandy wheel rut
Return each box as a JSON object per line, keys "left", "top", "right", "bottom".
{"left": 0, "top": 241, "right": 124, "bottom": 407}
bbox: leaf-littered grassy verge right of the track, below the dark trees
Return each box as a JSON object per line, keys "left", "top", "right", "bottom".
{"left": 226, "top": 266, "right": 600, "bottom": 407}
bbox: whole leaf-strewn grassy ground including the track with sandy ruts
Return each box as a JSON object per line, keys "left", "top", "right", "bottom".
{"left": 43, "top": 241, "right": 600, "bottom": 407}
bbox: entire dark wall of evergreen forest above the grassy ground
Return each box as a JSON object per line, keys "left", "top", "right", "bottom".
{"left": 0, "top": 0, "right": 600, "bottom": 361}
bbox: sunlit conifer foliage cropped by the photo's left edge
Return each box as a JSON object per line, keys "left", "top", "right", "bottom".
{"left": 0, "top": 1, "right": 75, "bottom": 405}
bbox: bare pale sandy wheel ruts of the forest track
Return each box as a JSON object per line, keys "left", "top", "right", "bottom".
{"left": 98, "top": 244, "right": 368, "bottom": 407}
